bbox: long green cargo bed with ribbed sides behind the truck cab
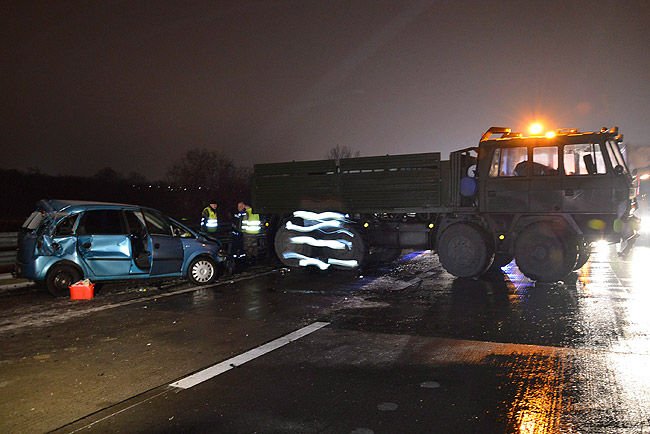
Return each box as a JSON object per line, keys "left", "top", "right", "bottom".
{"left": 253, "top": 152, "right": 442, "bottom": 214}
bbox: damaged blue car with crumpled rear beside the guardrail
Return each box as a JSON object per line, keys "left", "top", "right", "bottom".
{"left": 15, "top": 200, "right": 225, "bottom": 296}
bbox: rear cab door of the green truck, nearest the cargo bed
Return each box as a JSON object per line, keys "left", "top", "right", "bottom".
{"left": 481, "top": 145, "right": 530, "bottom": 212}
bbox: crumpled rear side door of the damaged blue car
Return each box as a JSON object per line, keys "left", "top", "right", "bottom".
{"left": 77, "top": 209, "right": 132, "bottom": 276}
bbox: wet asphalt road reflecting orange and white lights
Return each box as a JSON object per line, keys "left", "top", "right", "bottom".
{"left": 0, "top": 243, "right": 650, "bottom": 434}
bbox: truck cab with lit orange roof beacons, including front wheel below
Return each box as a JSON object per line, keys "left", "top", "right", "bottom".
{"left": 468, "top": 127, "right": 635, "bottom": 280}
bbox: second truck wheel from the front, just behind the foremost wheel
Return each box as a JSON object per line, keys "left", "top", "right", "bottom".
{"left": 438, "top": 223, "right": 494, "bottom": 277}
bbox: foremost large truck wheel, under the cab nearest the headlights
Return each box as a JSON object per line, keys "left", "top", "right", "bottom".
{"left": 515, "top": 223, "right": 578, "bottom": 282}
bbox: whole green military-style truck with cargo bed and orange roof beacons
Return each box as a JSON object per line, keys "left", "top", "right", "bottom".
{"left": 253, "top": 127, "right": 637, "bottom": 282}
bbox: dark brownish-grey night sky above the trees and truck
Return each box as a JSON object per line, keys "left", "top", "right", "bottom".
{"left": 0, "top": 0, "right": 650, "bottom": 179}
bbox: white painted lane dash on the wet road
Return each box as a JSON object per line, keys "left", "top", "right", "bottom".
{"left": 170, "top": 322, "right": 329, "bottom": 389}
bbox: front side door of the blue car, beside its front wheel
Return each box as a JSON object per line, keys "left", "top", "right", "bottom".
{"left": 142, "top": 209, "right": 183, "bottom": 276}
